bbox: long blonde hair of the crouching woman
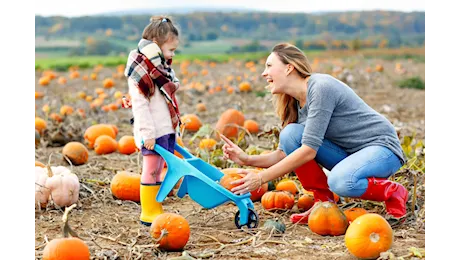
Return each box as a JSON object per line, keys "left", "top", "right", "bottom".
{"left": 272, "top": 43, "right": 313, "bottom": 128}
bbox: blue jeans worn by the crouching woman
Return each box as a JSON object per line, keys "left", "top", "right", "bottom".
{"left": 279, "top": 123, "right": 402, "bottom": 197}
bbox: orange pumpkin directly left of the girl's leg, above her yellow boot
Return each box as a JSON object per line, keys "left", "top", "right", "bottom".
{"left": 110, "top": 171, "right": 141, "bottom": 202}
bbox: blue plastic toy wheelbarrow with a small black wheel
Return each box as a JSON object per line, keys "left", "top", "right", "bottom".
{"left": 154, "top": 144, "right": 259, "bottom": 228}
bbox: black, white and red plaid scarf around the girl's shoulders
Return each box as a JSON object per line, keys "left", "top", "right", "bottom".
{"left": 125, "top": 39, "right": 181, "bottom": 129}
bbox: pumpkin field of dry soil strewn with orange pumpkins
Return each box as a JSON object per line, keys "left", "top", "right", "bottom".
{"left": 32, "top": 51, "right": 426, "bottom": 260}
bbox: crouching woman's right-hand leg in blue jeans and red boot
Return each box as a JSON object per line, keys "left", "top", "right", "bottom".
{"left": 328, "top": 146, "right": 408, "bottom": 218}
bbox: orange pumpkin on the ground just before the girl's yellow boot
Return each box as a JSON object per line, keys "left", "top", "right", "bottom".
{"left": 150, "top": 213, "right": 190, "bottom": 251}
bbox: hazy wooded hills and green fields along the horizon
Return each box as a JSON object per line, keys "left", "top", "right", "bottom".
{"left": 34, "top": 8, "right": 426, "bottom": 55}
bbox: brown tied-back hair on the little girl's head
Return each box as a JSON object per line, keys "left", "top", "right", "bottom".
{"left": 142, "top": 16, "right": 179, "bottom": 46}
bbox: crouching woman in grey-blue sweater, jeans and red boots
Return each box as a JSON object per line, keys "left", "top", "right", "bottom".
{"left": 222, "top": 43, "right": 408, "bottom": 223}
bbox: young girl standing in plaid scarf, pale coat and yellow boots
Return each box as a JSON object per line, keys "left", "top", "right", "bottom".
{"left": 124, "top": 16, "right": 180, "bottom": 226}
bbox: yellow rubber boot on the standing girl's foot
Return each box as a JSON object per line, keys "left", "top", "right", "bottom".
{"left": 140, "top": 183, "right": 163, "bottom": 226}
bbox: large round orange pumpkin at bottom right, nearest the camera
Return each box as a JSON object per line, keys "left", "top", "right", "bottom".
{"left": 344, "top": 213, "right": 393, "bottom": 259}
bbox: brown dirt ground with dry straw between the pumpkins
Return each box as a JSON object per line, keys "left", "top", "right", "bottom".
{"left": 34, "top": 55, "right": 426, "bottom": 260}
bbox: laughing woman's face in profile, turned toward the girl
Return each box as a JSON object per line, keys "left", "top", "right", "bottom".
{"left": 262, "top": 52, "right": 287, "bottom": 94}
